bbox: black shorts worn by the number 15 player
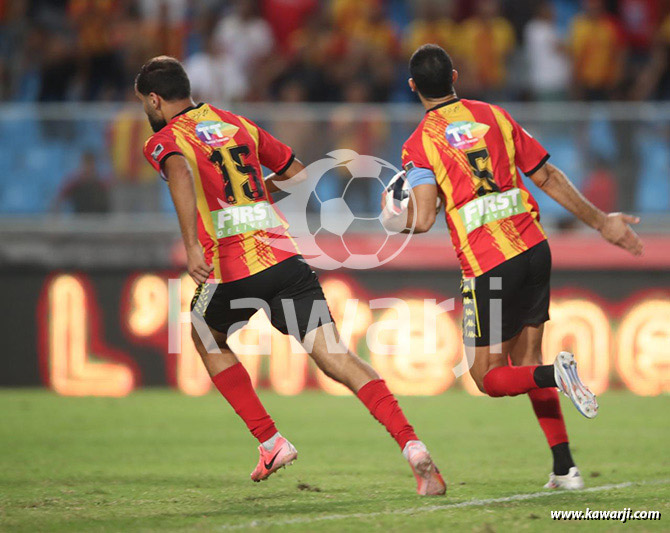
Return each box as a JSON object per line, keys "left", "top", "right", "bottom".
{"left": 191, "top": 255, "right": 333, "bottom": 340}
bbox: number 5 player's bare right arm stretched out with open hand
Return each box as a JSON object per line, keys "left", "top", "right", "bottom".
{"left": 531, "top": 163, "right": 643, "bottom": 255}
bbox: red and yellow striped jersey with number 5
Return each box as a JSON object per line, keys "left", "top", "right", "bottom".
{"left": 402, "top": 99, "right": 549, "bottom": 277}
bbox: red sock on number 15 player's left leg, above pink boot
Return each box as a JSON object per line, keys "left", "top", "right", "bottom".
{"left": 212, "top": 363, "right": 277, "bottom": 443}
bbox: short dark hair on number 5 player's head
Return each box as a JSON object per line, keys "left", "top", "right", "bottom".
{"left": 409, "top": 44, "right": 454, "bottom": 98}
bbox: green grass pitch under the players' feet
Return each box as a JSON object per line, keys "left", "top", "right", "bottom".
{"left": 0, "top": 389, "right": 670, "bottom": 532}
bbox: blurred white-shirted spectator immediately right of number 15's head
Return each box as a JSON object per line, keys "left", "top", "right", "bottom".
{"left": 184, "top": 31, "right": 248, "bottom": 106}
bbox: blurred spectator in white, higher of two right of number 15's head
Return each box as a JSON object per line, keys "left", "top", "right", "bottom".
{"left": 214, "top": 0, "right": 274, "bottom": 95}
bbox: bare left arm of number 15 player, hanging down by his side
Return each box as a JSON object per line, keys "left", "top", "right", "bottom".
{"left": 163, "top": 155, "right": 214, "bottom": 284}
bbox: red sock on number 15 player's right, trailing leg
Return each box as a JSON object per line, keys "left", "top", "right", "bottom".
{"left": 356, "top": 379, "right": 419, "bottom": 450}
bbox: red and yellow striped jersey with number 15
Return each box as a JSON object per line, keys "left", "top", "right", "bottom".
{"left": 144, "top": 104, "right": 299, "bottom": 283}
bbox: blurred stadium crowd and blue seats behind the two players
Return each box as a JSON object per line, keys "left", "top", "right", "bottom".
{"left": 0, "top": 0, "right": 670, "bottom": 220}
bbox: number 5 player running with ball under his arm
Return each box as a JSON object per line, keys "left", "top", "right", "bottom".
{"left": 382, "top": 44, "right": 642, "bottom": 489}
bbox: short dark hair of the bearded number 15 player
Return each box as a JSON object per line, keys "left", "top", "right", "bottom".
{"left": 135, "top": 56, "right": 191, "bottom": 102}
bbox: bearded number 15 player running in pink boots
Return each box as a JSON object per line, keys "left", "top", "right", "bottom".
{"left": 135, "top": 56, "right": 446, "bottom": 495}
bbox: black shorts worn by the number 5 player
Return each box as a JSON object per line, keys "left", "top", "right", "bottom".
{"left": 461, "top": 241, "right": 551, "bottom": 346}
